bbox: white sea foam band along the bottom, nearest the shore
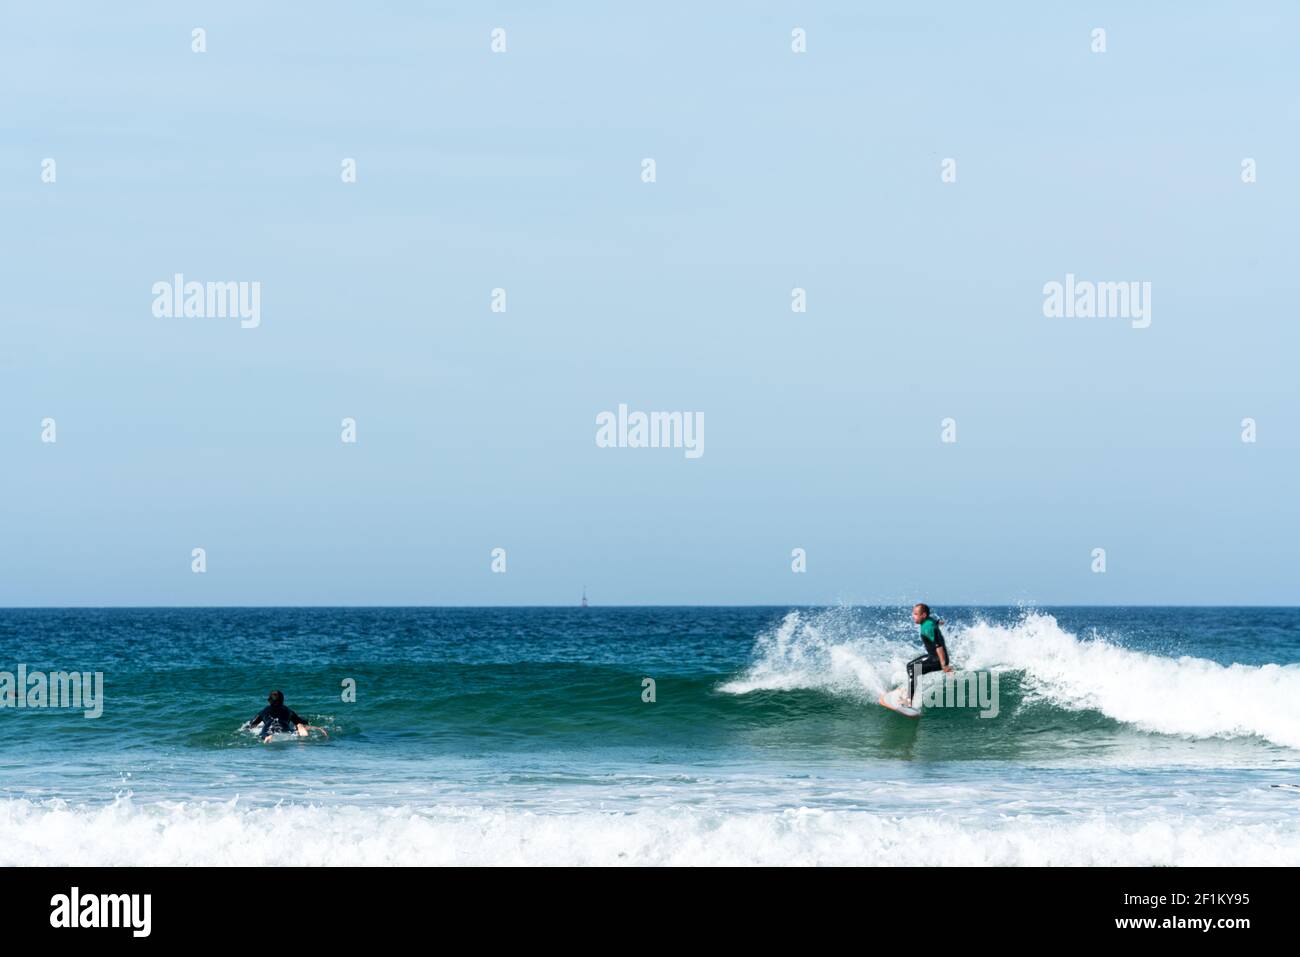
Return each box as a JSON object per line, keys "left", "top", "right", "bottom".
{"left": 0, "top": 792, "right": 1300, "bottom": 866}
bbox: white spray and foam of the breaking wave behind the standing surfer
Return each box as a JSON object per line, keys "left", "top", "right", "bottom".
{"left": 722, "top": 610, "right": 1300, "bottom": 749}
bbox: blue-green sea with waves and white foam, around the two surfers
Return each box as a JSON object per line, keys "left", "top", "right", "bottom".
{"left": 0, "top": 607, "right": 1300, "bottom": 865}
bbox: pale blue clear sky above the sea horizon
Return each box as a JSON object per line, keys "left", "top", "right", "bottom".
{"left": 0, "top": 1, "right": 1300, "bottom": 605}
